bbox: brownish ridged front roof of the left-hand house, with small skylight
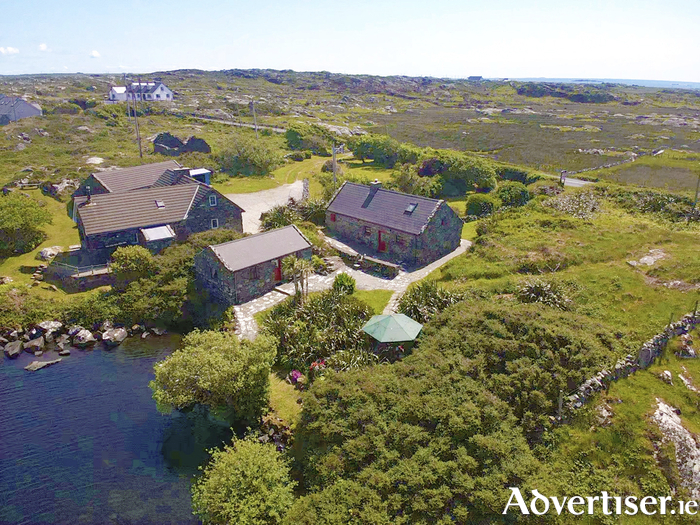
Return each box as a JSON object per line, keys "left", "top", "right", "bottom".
{"left": 75, "top": 184, "right": 204, "bottom": 235}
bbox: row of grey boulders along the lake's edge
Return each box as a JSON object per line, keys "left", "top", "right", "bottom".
{"left": 0, "top": 321, "right": 166, "bottom": 371}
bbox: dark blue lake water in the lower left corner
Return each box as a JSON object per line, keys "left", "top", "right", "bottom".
{"left": 0, "top": 335, "right": 231, "bottom": 525}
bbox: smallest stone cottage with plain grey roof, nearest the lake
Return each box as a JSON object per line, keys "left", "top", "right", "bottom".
{"left": 194, "top": 225, "right": 311, "bottom": 306}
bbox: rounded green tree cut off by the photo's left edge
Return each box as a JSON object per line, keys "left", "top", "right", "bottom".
{"left": 0, "top": 192, "right": 52, "bottom": 256}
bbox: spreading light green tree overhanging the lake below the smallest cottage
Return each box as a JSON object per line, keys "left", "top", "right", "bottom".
{"left": 149, "top": 330, "right": 277, "bottom": 424}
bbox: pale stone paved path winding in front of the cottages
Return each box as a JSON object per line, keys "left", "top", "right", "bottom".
{"left": 234, "top": 238, "right": 472, "bottom": 339}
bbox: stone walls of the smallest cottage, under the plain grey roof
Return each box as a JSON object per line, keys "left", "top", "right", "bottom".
{"left": 194, "top": 248, "right": 311, "bottom": 306}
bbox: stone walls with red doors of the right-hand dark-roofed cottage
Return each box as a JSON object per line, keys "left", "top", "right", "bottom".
{"left": 326, "top": 203, "right": 462, "bottom": 265}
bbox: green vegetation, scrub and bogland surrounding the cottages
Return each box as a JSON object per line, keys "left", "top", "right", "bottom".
{"left": 0, "top": 71, "right": 700, "bottom": 523}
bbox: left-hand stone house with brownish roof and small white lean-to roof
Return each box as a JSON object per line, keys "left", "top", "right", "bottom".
{"left": 75, "top": 182, "right": 244, "bottom": 252}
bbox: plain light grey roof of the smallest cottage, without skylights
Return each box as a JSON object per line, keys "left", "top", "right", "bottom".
{"left": 209, "top": 225, "right": 311, "bottom": 272}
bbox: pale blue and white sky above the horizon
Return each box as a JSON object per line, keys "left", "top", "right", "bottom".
{"left": 0, "top": 0, "right": 700, "bottom": 82}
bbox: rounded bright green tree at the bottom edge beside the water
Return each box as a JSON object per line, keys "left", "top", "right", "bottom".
{"left": 192, "top": 439, "right": 296, "bottom": 525}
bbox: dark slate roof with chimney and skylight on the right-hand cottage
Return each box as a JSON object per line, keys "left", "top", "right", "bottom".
{"left": 327, "top": 182, "right": 443, "bottom": 235}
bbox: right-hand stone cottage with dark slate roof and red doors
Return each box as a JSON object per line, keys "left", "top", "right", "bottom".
{"left": 326, "top": 181, "right": 462, "bottom": 266}
